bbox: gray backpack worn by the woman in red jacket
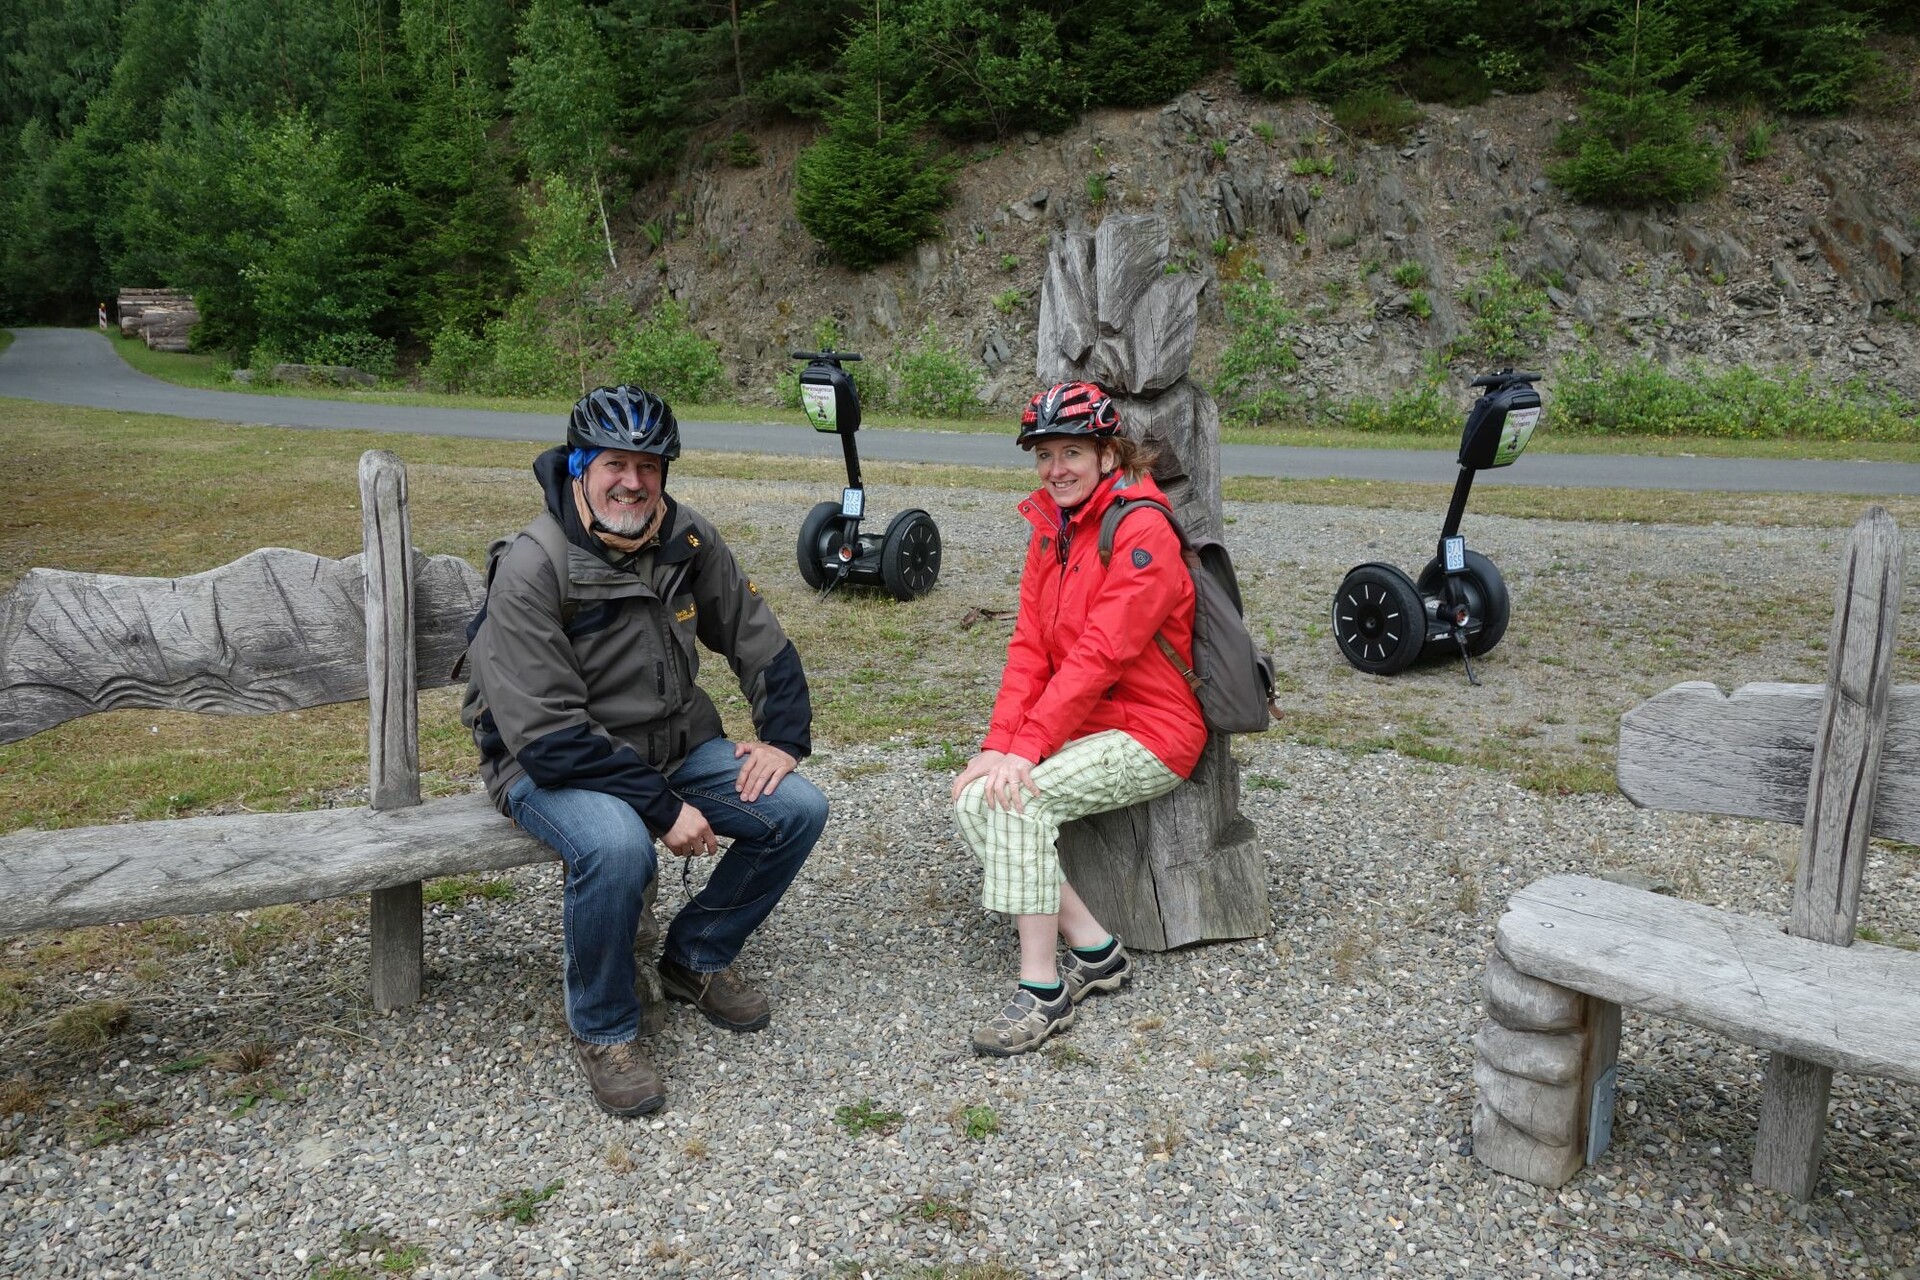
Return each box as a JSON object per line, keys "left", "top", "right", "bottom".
{"left": 1100, "top": 497, "right": 1279, "bottom": 733}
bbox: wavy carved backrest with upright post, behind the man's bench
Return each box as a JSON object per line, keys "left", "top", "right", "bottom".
{"left": 0, "top": 451, "right": 484, "bottom": 744}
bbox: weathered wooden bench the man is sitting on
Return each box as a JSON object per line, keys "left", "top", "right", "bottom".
{"left": 0, "top": 451, "right": 553, "bottom": 1009}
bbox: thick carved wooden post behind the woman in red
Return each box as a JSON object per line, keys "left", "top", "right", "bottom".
{"left": 1035, "top": 215, "right": 1273, "bottom": 950}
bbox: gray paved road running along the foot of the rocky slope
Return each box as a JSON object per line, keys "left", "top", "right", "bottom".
{"left": 0, "top": 328, "right": 1920, "bottom": 495}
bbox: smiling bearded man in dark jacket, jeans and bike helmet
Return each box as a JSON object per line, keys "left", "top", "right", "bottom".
{"left": 461, "top": 386, "right": 828, "bottom": 1115}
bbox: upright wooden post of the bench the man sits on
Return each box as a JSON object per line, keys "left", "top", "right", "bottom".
{"left": 359, "top": 449, "right": 422, "bottom": 1011}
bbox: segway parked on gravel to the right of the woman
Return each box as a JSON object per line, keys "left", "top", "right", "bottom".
{"left": 1332, "top": 368, "right": 1540, "bottom": 685}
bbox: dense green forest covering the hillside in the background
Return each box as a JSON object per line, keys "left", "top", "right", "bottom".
{"left": 0, "top": 0, "right": 1916, "bottom": 393}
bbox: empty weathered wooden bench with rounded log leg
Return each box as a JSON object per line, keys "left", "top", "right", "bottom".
{"left": 1473, "top": 507, "right": 1920, "bottom": 1199}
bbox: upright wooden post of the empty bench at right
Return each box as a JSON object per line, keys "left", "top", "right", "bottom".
{"left": 1753, "top": 507, "right": 1903, "bottom": 1199}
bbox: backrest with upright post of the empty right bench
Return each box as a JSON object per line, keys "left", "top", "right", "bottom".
{"left": 1617, "top": 507, "right": 1920, "bottom": 946}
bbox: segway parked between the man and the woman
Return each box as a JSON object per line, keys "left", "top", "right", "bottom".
{"left": 793, "top": 347, "right": 941, "bottom": 601}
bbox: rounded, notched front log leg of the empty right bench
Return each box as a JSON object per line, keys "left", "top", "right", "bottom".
{"left": 1473, "top": 952, "right": 1620, "bottom": 1186}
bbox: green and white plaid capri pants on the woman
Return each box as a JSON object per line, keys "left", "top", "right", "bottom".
{"left": 954, "top": 729, "right": 1181, "bottom": 915}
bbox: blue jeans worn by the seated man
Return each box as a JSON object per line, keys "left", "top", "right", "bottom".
{"left": 507, "top": 737, "right": 828, "bottom": 1044}
